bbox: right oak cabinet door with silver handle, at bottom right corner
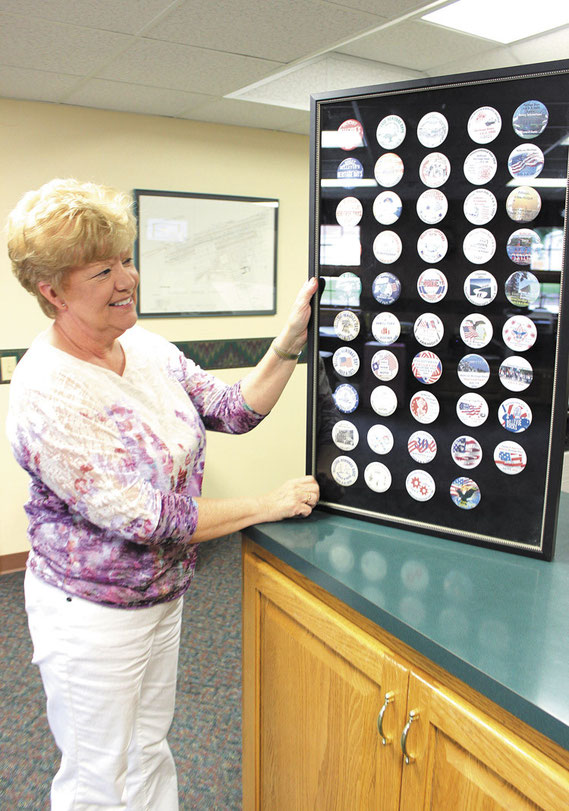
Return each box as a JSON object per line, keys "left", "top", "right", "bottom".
{"left": 401, "top": 673, "right": 569, "bottom": 811}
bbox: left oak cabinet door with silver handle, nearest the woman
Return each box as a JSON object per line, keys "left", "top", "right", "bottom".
{"left": 243, "top": 555, "right": 408, "bottom": 811}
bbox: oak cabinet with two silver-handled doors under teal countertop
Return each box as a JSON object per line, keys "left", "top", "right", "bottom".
{"left": 243, "top": 551, "right": 569, "bottom": 811}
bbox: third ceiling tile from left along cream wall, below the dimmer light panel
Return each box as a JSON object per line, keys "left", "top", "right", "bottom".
{"left": 180, "top": 98, "right": 309, "bottom": 130}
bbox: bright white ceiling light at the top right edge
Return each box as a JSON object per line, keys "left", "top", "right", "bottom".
{"left": 422, "top": 0, "right": 569, "bottom": 43}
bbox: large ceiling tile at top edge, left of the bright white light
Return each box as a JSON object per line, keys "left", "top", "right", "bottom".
{"left": 146, "top": 0, "right": 385, "bottom": 62}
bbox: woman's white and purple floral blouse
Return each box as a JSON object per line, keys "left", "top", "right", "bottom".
{"left": 7, "top": 326, "right": 262, "bottom": 608}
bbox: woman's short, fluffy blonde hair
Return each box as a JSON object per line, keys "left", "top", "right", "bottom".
{"left": 6, "top": 178, "right": 136, "bottom": 318}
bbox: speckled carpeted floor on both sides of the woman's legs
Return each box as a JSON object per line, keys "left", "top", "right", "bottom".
{"left": 0, "top": 534, "right": 241, "bottom": 811}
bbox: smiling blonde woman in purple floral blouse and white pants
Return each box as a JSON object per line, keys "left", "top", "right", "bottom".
{"left": 8, "top": 180, "right": 318, "bottom": 811}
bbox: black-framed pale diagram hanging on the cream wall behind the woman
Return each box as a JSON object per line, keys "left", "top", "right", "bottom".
{"left": 134, "top": 189, "right": 279, "bottom": 318}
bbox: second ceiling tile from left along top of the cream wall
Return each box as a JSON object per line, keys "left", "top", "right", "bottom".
{"left": 64, "top": 79, "right": 207, "bottom": 116}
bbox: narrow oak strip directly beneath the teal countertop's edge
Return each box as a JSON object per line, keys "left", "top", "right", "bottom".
{"left": 243, "top": 533, "right": 569, "bottom": 769}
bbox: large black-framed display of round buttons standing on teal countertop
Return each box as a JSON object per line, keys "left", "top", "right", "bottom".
{"left": 307, "top": 61, "right": 569, "bottom": 559}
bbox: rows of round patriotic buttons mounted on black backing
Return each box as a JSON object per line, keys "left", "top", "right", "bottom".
{"left": 331, "top": 100, "right": 549, "bottom": 510}
